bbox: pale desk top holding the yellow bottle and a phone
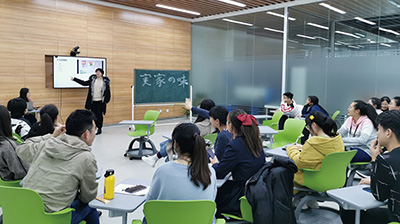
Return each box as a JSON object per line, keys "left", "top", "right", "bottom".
{"left": 89, "top": 178, "right": 151, "bottom": 213}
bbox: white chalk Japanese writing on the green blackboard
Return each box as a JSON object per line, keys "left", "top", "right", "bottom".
{"left": 140, "top": 73, "right": 189, "bottom": 88}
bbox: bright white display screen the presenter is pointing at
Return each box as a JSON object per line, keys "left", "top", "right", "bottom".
{"left": 53, "top": 56, "right": 107, "bottom": 88}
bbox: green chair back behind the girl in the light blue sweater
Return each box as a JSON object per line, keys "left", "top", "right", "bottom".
{"left": 132, "top": 200, "right": 225, "bottom": 224}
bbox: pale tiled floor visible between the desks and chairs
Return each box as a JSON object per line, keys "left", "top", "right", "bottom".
{"left": 71, "top": 118, "right": 340, "bottom": 224}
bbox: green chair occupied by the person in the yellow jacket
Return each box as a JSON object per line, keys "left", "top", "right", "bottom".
{"left": 293, "top": 150, "right": 356, "bottom": 220}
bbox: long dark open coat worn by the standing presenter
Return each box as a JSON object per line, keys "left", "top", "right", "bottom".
{"left": 73, "top": 75, "right": 111, "bottom": 114}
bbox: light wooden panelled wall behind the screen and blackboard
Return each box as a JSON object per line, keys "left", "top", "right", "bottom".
{"left": 0, "top": 0, "right": 191, "bottom": 124}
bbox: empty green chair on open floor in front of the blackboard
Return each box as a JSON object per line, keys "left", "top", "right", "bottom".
{"left": 124, "top": 110, "right": 160, "bottom": 160}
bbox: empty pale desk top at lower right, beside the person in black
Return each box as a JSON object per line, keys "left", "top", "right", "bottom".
{"left": 326, "top": 185, "right": 386, "bottom": 210}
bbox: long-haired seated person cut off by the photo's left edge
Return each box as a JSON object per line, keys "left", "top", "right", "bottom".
{"left": 0, "top": 105, "right": 29, "bottom": 181}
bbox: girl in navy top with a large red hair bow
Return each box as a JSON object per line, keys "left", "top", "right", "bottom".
{"left": 211, "top": 110, "right": 265, "bottom": 214}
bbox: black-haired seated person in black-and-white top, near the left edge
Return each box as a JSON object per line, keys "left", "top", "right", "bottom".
{"left": 7, "top": 98, "right": 31, "bottom": 139}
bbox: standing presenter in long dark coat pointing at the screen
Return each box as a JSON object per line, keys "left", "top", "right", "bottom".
{"left": 71, "top": 68, "right": 111, "bottom": 135}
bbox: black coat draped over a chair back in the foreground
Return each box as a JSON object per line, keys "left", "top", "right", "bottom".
{"left": 245, "top": 158, "right": 297, "bottom": 224}
